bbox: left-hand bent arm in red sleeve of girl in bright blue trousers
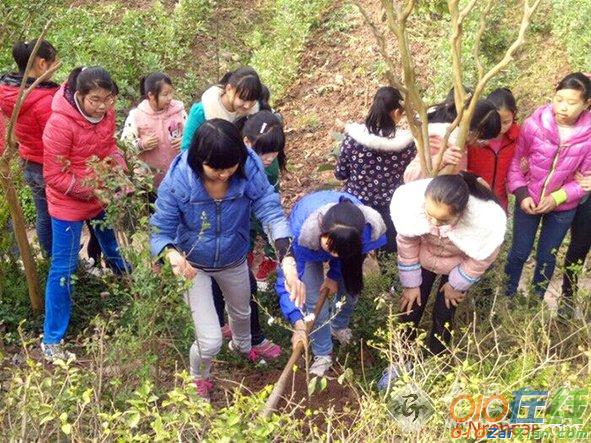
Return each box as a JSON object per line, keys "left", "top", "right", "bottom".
{"left": 43, "top": 120, "right": 94, "bottom": 200}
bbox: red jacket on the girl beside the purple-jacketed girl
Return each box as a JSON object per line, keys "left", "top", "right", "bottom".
{"left": 468, "top": 123, "right": 520, "bottom": 211}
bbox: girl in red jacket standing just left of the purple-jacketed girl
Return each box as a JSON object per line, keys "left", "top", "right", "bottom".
{"left": 468, "top": 88, "right": 519, "bottom": 212}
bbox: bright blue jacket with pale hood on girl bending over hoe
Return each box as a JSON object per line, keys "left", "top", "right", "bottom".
{"left": 275, "top": 191, "right": 386, "bottom": 324}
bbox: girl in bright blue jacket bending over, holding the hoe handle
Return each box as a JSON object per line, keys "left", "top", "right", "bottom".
{"left": 276, "top": 191, "right": 386, "bottom": 377}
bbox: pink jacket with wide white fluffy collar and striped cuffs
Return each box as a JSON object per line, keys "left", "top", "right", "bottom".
{"left": 390, "top": 179, "right": 507, "bottom": 291}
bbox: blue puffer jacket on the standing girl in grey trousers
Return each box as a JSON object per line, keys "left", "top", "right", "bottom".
{"left": 150, "top": 149, "right": 291, "bottom": 269}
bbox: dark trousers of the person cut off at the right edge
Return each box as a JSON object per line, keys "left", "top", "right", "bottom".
{"left": 562, "top": 197, "right": 591, "bottom": 297}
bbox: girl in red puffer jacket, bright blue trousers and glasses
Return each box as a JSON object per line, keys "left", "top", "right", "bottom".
{"left": 42, "top": 67, "right": 126, "bottom": 360}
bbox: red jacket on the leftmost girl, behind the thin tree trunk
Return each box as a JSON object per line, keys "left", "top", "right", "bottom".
{"left": 0, "top": 74, "right": 59, "bottom": 164}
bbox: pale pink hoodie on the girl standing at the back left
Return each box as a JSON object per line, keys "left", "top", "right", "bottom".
{"left": 121, "top": 100, "right": 186, "bottom": 189}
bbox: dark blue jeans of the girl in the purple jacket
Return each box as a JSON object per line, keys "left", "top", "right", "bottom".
{"left": 505, "top": 205, "right": 576, "bottom": 298}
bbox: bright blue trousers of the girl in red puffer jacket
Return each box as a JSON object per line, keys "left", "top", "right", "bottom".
{"left": 43, "top": 214, "right": 128, "bottom": 344}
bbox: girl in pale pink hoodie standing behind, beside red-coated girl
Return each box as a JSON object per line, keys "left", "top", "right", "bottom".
{"left": 121, "top": 72, "right": 187, "bottom": 191}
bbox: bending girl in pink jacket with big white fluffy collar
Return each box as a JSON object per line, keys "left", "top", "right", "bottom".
{"left": 378, "top": 172, "right": 507, "bottom": 389}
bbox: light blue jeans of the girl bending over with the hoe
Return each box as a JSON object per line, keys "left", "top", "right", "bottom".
{"left": 302, "top": 262, "right": 359, "bottom": 356}
